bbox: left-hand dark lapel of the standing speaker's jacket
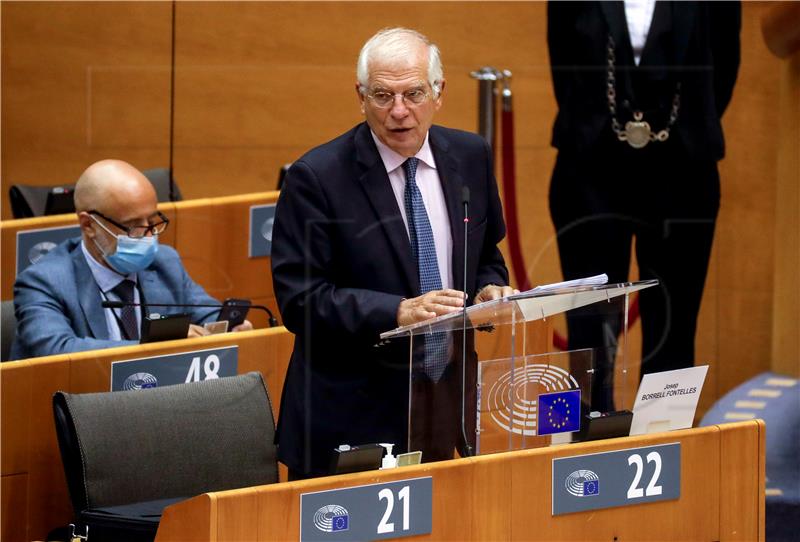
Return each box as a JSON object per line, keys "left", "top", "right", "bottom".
{"left": 355, "top": 124, "right": 420, "bottom": 293}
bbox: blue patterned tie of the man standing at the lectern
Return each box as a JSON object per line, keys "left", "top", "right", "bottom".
{"left": 403, "top": 158, "right": 448, "bottom": 382}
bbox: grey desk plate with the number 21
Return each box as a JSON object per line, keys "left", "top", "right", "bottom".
{"left": 300, "top": 476, "right": 433, "bottom": 542}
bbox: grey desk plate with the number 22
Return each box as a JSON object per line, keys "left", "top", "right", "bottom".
{"left": 552, "top": 442, "right": 681, "bottom": 516}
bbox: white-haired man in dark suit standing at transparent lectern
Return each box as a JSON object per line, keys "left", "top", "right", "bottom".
{"left": 272, "top": 28, "right": 512, "bottom": 479}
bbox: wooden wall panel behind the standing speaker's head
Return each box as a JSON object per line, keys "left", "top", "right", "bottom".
{"left": 175, "top": 2, "right": 553, "bottom": 202}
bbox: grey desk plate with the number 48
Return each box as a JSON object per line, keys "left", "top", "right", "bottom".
{"left": 111, "top": 346, "right": 239, "bottom": 391}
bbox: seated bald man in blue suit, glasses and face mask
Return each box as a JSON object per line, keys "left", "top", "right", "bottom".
{"left": 11, "top": 160, "right": 252, "bottom": 359}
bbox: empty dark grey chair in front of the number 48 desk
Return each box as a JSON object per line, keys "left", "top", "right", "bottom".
{"left": 53, "top": 372, "right": 278, "bottom": 542}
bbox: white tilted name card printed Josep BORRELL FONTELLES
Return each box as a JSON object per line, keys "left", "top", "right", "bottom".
{"left": 630, "top": 365, "right": 708, "bottom": 435}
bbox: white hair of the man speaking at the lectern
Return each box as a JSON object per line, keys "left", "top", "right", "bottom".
{"left": 356, "top": 27, "right": 444, "bottom": 98}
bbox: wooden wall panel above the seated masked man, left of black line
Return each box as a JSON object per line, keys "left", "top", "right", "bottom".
{"left": 1, "top": 2, "right": 171, "bottom": 218}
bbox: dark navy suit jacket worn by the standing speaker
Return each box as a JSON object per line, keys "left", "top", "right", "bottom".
{"left": 272, "top": 124, "right": 508, "bottom": 474}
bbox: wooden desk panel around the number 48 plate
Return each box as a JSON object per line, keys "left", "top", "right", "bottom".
{"left": 0, "top": 327, "right": 294, "bottom": 541}
